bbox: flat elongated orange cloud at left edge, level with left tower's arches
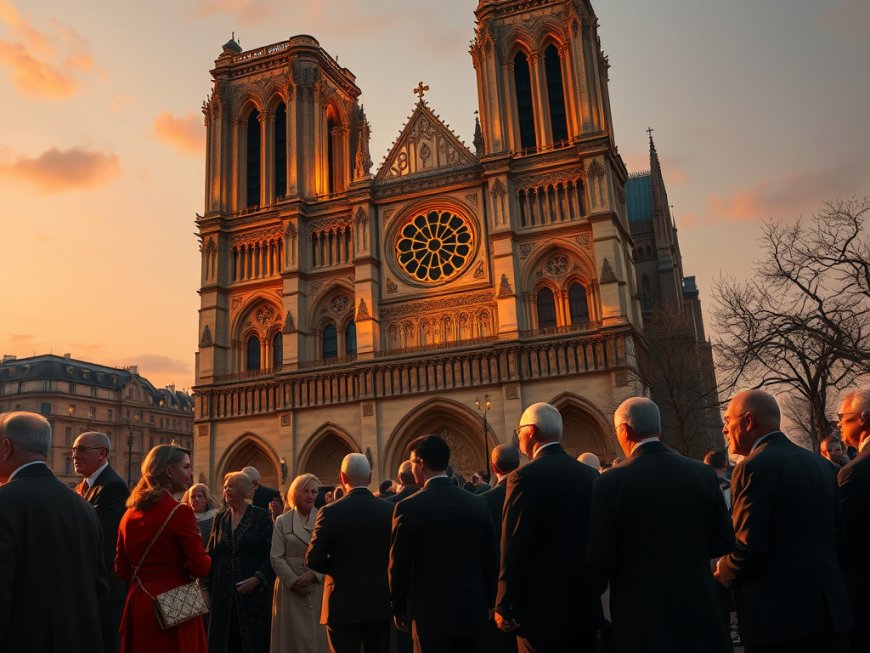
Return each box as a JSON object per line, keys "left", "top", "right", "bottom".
{"left": 0, "top": 147, "right": 121, "bottom": 195}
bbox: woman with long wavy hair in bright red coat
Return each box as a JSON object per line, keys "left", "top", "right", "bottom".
{"left": 115, "top": 445, "right": 211, "bottom": 653}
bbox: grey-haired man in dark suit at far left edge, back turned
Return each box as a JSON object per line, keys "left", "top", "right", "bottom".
{"left": 0, "top": 412, "right": 107, "bottom": 653}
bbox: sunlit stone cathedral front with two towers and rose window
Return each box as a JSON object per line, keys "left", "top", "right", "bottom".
{"left": 194, "top": 0, "right": 720, "bottom": 488}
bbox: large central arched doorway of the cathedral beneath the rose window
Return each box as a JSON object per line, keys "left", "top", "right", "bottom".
{"left": 382, "top": 398, "right": 498, "bottom": 480}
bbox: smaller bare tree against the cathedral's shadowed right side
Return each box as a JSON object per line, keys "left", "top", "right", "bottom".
{"left": 637, "top": 306, "right": 722, "bottom": 458}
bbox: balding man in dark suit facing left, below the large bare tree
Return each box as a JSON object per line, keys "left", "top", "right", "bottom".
{"left": 716, "top": 390, "right": 852, "bottom": 653}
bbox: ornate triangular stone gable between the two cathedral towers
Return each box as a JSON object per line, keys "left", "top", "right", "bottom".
{"left": 376, "top": 99, "right": 477, "bottom": 181}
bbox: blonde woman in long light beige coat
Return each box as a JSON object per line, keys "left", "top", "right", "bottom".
{"left": 269, "top": 474, "right": 329, "bottom": 653}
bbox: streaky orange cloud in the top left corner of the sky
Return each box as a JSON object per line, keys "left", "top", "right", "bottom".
{"left": 0, "top": 0, "right": 96, "bottom": 100}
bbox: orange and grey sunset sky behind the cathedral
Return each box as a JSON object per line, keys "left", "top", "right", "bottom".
{"left": 0, "top": 0, "right": 870, "bottom": 387}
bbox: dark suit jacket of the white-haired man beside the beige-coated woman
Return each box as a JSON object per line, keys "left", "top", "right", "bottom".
{"left": 305, "top": 488, "right": 393, "bottom": 625}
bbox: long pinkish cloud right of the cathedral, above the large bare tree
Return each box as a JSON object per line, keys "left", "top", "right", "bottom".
{"left": 705, "top": 162, "right": 866, "bottom": 222}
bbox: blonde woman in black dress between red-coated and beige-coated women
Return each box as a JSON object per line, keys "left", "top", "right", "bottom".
{"left": 207, "top": 472, "right": 275, "bottom": 653}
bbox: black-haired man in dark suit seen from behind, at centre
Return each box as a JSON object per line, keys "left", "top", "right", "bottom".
{"left": 390, "top": 435, "right": 497, "bottom": 653}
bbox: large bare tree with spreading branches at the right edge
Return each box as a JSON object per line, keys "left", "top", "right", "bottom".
{"left": 713, "top": 198, "right": 870, "bottom": 449}
